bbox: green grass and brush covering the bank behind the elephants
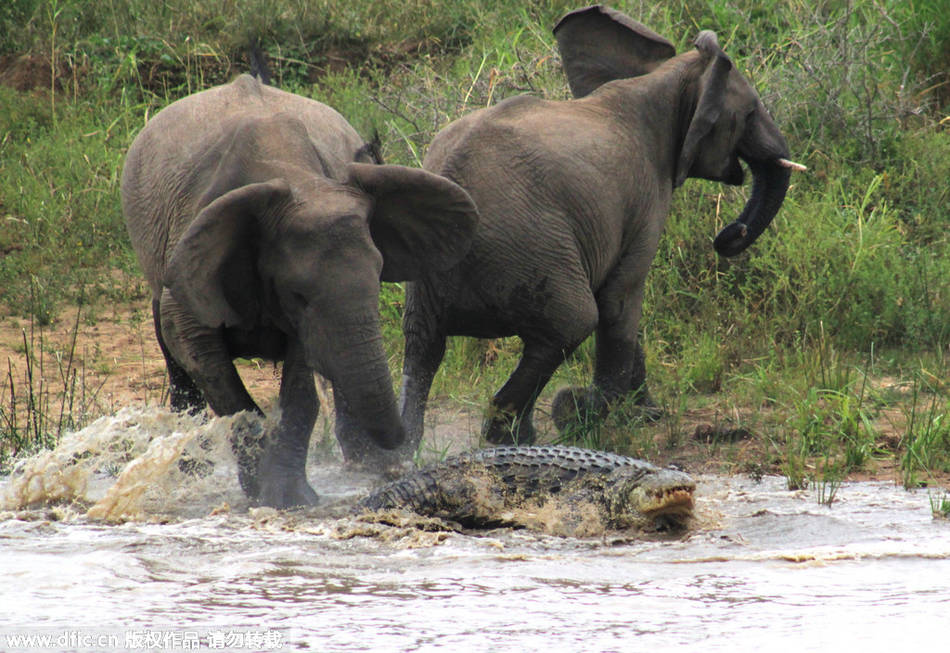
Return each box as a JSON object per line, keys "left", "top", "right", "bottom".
{"left": 0, "top": 0, "right": 950, "bottom": 488}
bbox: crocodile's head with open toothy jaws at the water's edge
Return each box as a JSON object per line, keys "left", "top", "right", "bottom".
{"left": 605, "top": 467, "right": 696, "bottom": 528}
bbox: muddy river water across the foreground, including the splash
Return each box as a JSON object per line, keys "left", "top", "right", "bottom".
{"left": 0, "top": 410, "right": 950, "bottom": 651}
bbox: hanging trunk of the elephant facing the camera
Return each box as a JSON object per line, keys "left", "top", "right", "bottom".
{"left": 325, "top": 319, "right": 405, "bottom": 449}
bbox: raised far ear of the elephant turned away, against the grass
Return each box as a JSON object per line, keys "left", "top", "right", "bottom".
{"left": 554, "top": 5, "right": 676, "bottom": 98}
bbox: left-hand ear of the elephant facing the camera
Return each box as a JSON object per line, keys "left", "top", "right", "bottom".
{"left": 164, "top": 179, "right": 290, "bottom": 327}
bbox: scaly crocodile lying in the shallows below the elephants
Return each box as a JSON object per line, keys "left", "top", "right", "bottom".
{"left": 358, "top": 446, "right": 696, "bottom": 535}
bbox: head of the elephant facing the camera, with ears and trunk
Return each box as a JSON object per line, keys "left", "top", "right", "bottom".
{"left": 164, "top": 163, "right": 478, "bottom": 448}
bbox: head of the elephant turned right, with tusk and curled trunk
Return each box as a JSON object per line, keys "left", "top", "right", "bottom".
{"left": 554, "top": 5, "right": 804, "bottom": 256}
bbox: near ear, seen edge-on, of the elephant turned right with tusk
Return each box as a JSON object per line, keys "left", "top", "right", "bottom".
{"left": 675, "top": 30, "right": 732, "bottom": 187}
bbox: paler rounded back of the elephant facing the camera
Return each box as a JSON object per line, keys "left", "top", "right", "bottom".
{"left": 122, "top": 75, "right": 364, "bottom": 296}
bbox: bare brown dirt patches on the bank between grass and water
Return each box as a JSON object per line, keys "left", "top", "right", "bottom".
{"left": 0, "top": 300, "right": 950, "bottom": 487}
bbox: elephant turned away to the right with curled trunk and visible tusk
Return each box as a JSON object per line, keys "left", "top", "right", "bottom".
{"left": 390, "top": 5, "right": 802, "bottom": 450}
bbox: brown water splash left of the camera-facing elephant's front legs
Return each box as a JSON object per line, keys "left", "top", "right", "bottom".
{"left": 0, "top": 408, "right": 258, "bottom": 521}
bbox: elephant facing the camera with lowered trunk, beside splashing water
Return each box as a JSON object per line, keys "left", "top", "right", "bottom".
{"left": 121, "top": 75, "right": 478, "bottom": 507}
